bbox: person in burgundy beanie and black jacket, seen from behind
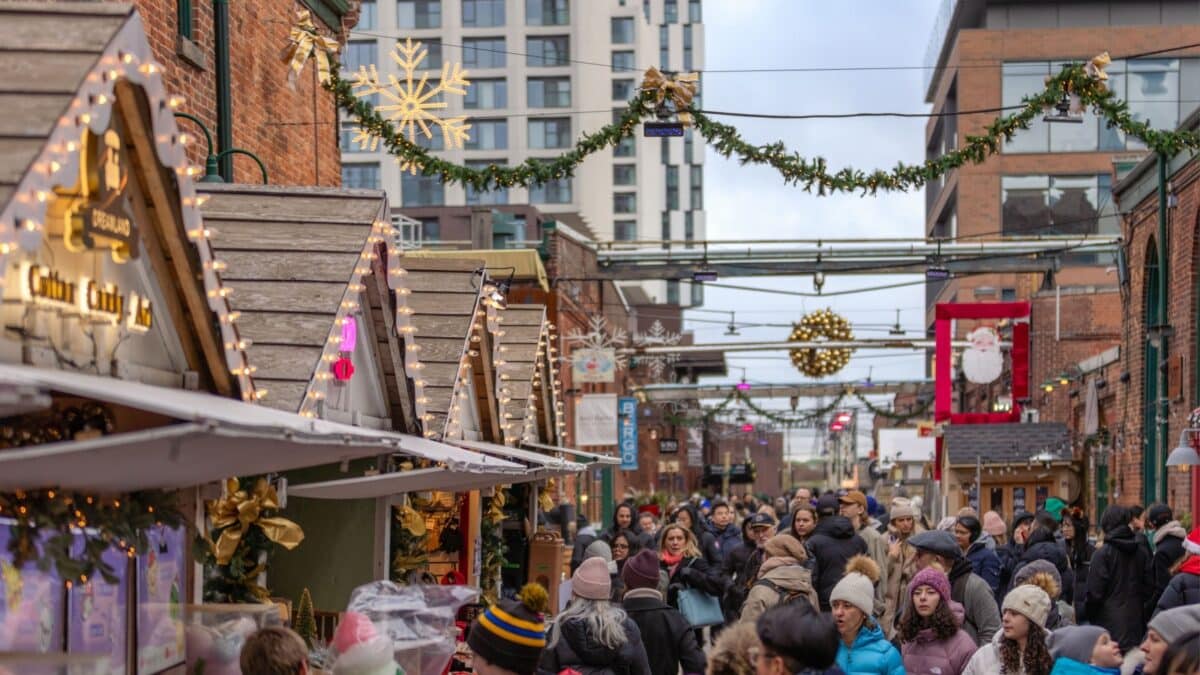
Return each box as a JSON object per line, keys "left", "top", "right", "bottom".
{"left": 620, "top": 550, "right": 706, "bottom": 675}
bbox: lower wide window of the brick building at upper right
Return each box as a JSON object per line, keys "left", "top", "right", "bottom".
{"left": 1001, "top": 174, "right": 1121, "bottom": 237}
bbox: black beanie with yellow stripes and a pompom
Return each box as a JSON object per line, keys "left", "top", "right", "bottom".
{"left": 467, "top": 584, "right": 550, "bottom": 675}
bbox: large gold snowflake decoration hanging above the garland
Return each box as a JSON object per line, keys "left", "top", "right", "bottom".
{"left": 354, "top": 38, "right": 470, "bottom": 174}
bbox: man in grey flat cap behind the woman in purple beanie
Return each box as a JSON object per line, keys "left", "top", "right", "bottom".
{"left": 908, "top": 530, "right": 1000, "bottom": 646}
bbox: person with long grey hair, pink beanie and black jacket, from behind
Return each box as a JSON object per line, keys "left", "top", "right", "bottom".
{"left": 538, "top": 557, "right": 652, "bottom": 675}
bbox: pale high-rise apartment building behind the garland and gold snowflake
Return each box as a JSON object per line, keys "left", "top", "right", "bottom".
{"left": 342, "top": 0, "right": 704, "bottom": 305}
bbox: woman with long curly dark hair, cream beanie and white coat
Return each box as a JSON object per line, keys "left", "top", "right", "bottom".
{"left": 962, "top": 584, "right": 1054, "bottom": 675}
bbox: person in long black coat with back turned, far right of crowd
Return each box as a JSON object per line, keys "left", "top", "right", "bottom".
{"left": 1085, "top": 506, "right": 1151, "bottom": 651}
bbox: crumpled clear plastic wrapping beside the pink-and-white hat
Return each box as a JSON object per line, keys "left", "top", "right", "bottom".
{"left": 334, "top": 581, "right": 479, "bottom": 675}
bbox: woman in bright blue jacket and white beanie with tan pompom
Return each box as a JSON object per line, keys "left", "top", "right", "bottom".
{"left": 829, "top": 555, "right": 905, "bottom": 675}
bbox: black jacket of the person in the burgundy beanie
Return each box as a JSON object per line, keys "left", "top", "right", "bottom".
{"left": 624, "top": 589, "right": 706, "bottom": 675}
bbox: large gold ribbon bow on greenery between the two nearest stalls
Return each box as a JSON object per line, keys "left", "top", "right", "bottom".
{"left": 204, "top": 478, "right": 304, "bottom": 565}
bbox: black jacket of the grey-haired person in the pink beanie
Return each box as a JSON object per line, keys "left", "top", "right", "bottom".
{"left": 538, "top": 617, "right": 650, "bottom": 675}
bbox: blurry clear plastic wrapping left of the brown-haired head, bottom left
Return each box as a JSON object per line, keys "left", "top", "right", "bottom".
{"left": 184, "top": 604, "right": 282, "bottom": 675}
